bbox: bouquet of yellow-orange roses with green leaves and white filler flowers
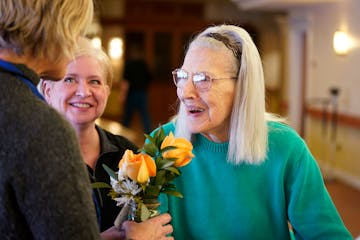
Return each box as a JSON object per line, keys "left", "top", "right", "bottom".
{"left": 98, "top": 127, "right": 194, "bottom": 227}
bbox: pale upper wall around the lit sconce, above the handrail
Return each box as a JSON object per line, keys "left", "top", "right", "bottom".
{"left": 307, "top": 0, "right": 360, "bottom": 117}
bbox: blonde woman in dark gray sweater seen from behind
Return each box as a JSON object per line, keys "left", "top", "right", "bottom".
{"left": 0, "top": 0, "right": 100, "bottom": 240}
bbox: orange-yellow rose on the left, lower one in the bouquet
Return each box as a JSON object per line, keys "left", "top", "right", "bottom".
{"left": 119, "top": 150, "right": 156, "bottom": 183}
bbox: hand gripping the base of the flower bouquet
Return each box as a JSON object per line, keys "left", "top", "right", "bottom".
{"left": 122, "top": 213, "right": 174, "bottom": 240}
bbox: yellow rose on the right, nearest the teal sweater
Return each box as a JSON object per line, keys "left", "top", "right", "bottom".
{"left": 160, "top": 132, "right": 194, "bottom": 167}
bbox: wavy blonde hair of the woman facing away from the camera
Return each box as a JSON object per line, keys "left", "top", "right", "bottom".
{"left": 0, "top": 0, "right": 94, "bottom": 62}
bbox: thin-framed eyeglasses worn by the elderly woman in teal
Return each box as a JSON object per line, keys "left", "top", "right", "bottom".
{"left": 172, "top": 68, "right": 237, "bottom": 91}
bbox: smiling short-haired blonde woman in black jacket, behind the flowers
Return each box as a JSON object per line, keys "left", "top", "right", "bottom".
{"left": 42, "top": 39, "right": 172, "bottom": 240}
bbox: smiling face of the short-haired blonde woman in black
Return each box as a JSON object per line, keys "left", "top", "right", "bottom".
{"left": 45, "top": 56, "right": 110, "bottom": 125}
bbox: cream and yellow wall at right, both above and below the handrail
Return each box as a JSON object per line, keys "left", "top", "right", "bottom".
{"left": 304, "top": 0, "right": 360, "bottom": 189}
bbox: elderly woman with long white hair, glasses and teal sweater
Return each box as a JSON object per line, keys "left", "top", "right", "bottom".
{"left": 155, "top": 25, "right": 351, "bottom": 240}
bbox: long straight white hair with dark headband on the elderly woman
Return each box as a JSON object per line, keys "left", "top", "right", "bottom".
{"left": 176, "top": 25, "right": 280, "bottom": 164}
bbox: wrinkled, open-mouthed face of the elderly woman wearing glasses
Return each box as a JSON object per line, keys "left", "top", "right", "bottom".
{"left": 177, "top": 46, "right": 236, "bottom": 142}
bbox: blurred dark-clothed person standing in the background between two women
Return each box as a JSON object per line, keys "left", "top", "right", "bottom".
{"left": 120, "top": 44, "right": 152, "bottom": 133}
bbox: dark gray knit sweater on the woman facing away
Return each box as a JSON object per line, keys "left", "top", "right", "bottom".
{"left": 0, "top": 62, "right": 100, "bottom": 240}
